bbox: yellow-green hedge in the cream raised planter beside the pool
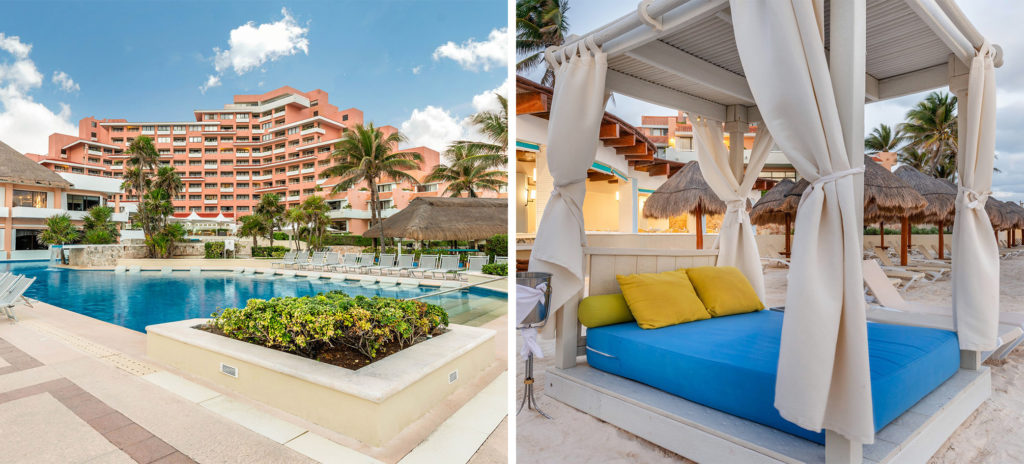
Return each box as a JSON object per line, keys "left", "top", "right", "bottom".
{"left": 211, "top": 291, "right": 449, "bottom": 360}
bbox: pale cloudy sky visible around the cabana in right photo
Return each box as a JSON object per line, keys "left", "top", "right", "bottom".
{"left": 526, "top": 0, "right": 1024, "bottom": 201}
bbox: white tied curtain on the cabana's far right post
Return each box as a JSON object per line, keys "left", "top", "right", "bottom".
{"left": 952, "top": 42, "right": 999, "bottom": 351}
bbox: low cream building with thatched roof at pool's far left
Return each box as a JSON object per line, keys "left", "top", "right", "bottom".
{"left": 0, "top": 140, "right": 128, "bottom": 260}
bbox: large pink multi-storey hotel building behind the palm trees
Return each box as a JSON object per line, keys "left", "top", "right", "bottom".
{"left": 26, "top": 87, "right": 507, "bottom": 234}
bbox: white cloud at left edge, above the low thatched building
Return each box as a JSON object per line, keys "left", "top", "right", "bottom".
{"left": 0, "top": 34, "right": 78, "bottom": 154}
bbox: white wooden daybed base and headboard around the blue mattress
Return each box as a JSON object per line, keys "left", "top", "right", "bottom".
{"left": 545, "top": 248, "right": 991, "bottom": 464}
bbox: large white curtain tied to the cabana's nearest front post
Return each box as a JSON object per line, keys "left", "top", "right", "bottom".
{"left": 730, "top": 0, "right": 874, "bottom": 444}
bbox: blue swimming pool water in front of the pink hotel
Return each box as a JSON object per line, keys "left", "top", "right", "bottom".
{"left": 0, "top": 262, "right": 507, "bottom": 332}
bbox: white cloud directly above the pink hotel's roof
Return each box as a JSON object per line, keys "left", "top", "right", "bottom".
{"left": 201, "top": 8, "right": 309, "bottom": 88}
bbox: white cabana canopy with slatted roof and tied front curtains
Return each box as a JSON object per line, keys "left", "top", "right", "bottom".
{"left": 530, "top": 0, "right": 1001, "bottom": 450}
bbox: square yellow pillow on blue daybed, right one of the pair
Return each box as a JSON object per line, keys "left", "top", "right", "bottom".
{"left": 686, "top": 266, "right": 765, "bottom": 318}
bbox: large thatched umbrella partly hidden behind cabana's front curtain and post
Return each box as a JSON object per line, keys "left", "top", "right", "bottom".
{"left": 782, "top": 156, "right": 928, "bottom": 265}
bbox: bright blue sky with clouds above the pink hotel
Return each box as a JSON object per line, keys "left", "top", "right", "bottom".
{"left": 0, "top": 0, "right": 508, "bottom": 152}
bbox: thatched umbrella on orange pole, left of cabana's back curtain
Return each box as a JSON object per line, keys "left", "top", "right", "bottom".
{"left": 643, "top": 162, "right": 726, "bottom": 250}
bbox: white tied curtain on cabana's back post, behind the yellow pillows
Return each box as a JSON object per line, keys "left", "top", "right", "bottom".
{"left": 693, "top": 118, "right": 772, "bottom": 301}
